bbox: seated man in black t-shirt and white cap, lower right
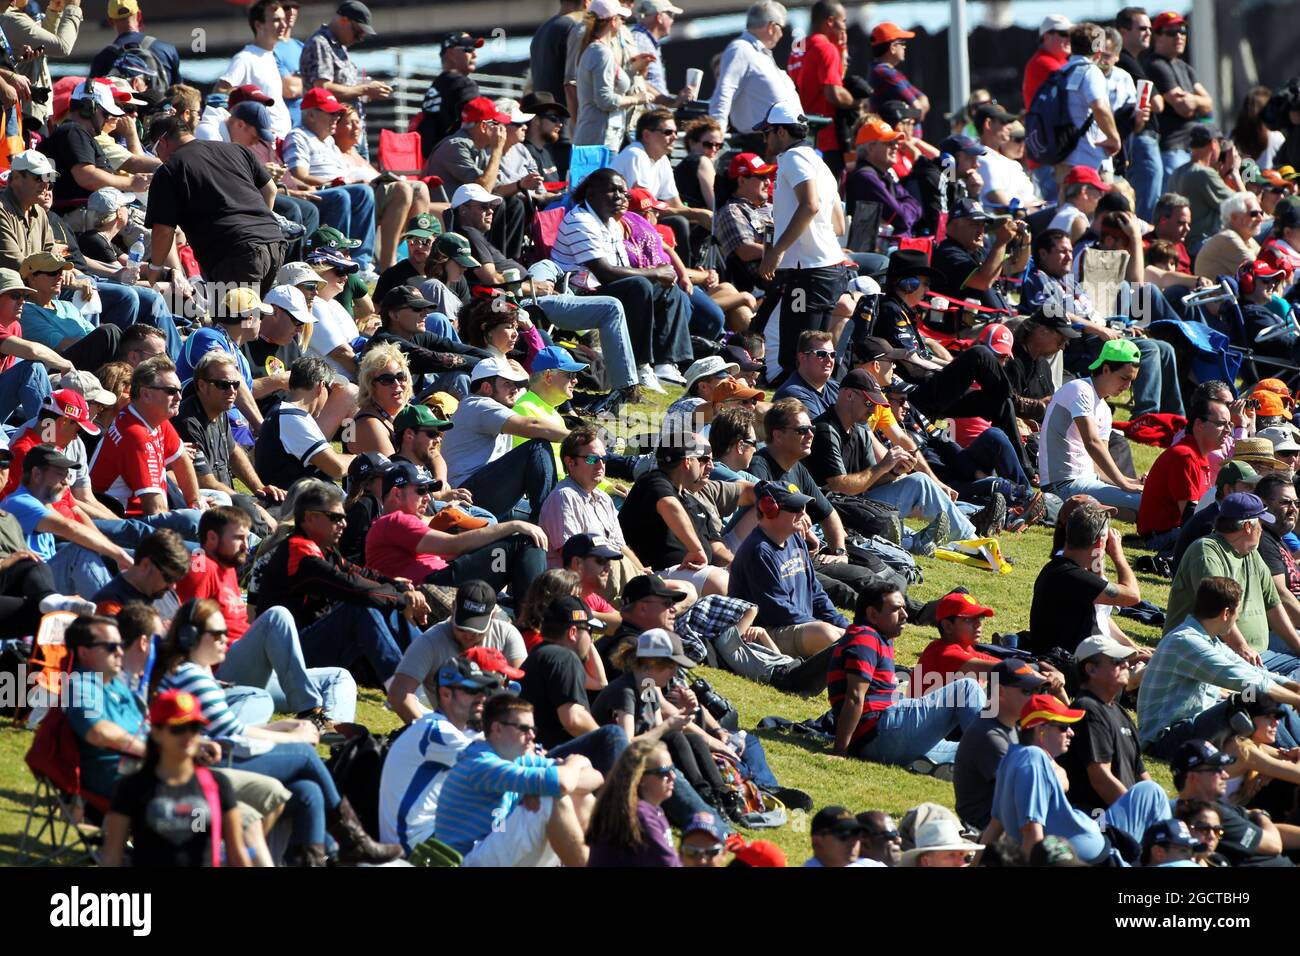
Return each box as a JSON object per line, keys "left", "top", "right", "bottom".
{"left": 1061, "top": 635, "right": 1151, "bottom": 813}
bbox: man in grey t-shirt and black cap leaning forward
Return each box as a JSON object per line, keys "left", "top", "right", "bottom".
{"left": 387, "top": 581, "right": 527, "bottom": 723}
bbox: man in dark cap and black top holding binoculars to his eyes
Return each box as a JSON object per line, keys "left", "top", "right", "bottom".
{"left": 933, "top": 199, "right": 1030, "bottom": 312}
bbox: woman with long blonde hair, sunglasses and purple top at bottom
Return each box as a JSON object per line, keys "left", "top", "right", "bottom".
{"left": 586, "top": 739, "right": 681, "bottom": 866}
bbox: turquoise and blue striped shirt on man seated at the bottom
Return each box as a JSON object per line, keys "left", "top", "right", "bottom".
{"left": 434, "top": 740, "right": 560, "bottom": 853}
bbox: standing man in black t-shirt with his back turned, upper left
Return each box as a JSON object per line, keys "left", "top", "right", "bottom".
{"left": 144, "top": 116, "right": 287, "bottom": 294}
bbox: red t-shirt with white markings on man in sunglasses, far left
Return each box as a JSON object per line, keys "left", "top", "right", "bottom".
{"left": 90, "top": 405, "right": 185, "bottom": 516}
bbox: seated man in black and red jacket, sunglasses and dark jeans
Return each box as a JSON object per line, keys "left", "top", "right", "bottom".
{"left": 248, "top": 481, "right": 429, "bottom": 684}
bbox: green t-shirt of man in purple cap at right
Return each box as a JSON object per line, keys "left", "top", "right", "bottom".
{"left": 1165, "top": 532, "right": 1281, "bottom": 652}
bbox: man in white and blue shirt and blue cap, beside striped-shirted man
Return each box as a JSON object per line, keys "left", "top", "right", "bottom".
{"left": 380, "top": 654, "right": 502, "bottom": 856}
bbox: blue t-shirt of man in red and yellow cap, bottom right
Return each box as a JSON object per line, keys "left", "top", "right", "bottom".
{"left": 993, "top": 744, "right": 1106, "bottom": 861}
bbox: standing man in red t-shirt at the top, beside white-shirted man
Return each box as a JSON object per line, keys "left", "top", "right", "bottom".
{"left": 787, "top": 0, "right": 857, "bottom": 182}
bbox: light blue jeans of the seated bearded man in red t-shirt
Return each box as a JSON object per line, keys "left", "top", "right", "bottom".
{"left": 220, "top": 607, "right": 356, "bottom": 723}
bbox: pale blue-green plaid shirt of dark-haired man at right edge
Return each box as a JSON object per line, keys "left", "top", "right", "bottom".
{"left": 1138, "top": 617, "right": 1282, "bottom": 749}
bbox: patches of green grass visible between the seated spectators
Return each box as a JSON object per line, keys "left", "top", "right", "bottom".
{"left": 0, "top": 399, "right": 1171, "bottom": 865}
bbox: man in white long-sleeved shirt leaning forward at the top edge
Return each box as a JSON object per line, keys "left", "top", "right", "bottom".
{"left": 709, "top": 0, "right": 795, "bottom": 136}
